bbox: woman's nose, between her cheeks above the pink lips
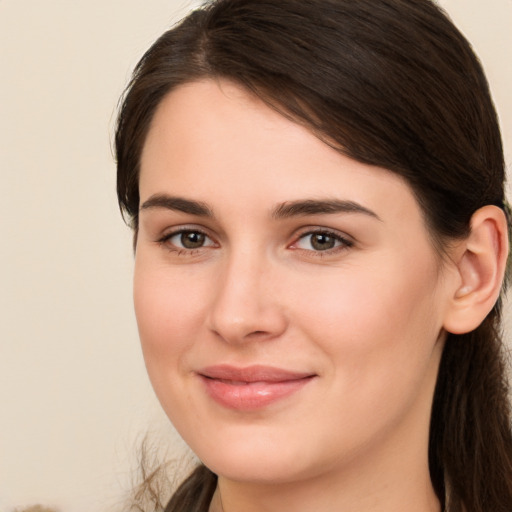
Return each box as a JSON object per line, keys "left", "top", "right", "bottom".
{"left": 208, "top": 251, "right": 288, "bottom": 343}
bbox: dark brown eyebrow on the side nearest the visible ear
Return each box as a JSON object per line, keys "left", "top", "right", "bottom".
{"left": 272, "top": 199, "right": 381, "bottom": 220}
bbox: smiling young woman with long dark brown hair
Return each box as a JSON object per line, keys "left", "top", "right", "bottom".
{"left": 116, "top": 0, "right": 512, "bottom": 512}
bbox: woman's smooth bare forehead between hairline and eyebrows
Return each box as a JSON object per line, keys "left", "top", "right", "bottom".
{"left": 140, "top": 80, "right": 419, "bottom": 228}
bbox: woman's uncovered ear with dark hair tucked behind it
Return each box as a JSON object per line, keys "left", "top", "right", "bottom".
{"left": 443, "top": 205, "right": 508, "bottom": 334}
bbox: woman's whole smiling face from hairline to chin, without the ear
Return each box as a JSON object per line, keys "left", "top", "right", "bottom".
{"left": 134, "top": 81, "right": 453, "bottom": 482}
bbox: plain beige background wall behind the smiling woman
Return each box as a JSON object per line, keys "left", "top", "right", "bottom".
{"left": 0, "top": 0, "right": 512, "bottom": 512}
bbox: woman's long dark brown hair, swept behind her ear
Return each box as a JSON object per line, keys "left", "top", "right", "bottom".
{"left": 115, "top": 0, "right": 512, "bottom": 512}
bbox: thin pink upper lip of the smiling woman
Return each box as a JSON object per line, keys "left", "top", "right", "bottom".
{"left": 197, "top": 364, "right": 315, "bottom": 382}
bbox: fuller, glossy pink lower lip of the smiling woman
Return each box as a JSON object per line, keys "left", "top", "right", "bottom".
{"left": 201, "top": 376, "right": 313, "bottom": 411}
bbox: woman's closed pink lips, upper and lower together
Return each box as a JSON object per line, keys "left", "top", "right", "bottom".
{"left": 197, "top": 365, "right": 315, "bottom": 411}
